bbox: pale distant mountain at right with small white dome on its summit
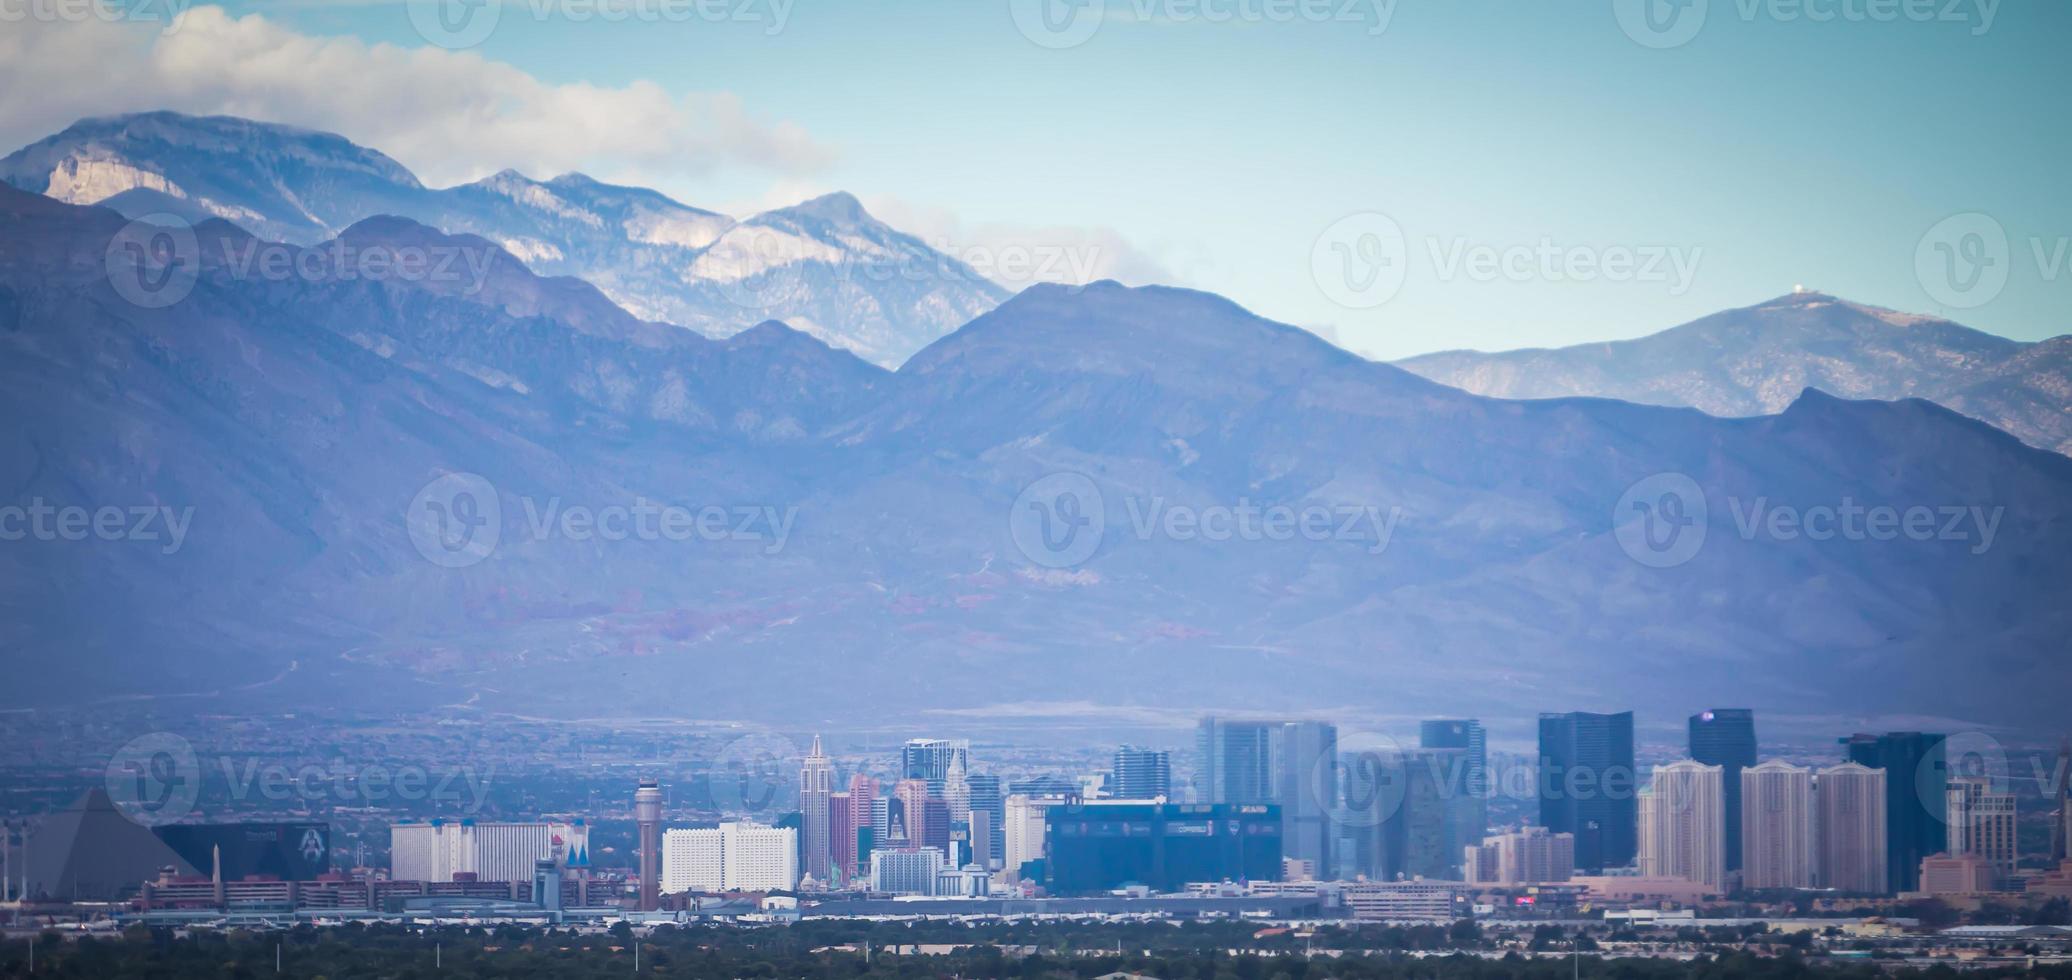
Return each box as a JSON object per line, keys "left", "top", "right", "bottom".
{"left": 1397, "top": 292, "right": 2072, "bottom": 454}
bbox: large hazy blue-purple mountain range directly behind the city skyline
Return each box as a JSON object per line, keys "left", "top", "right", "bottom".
{"left": 0, "top": 183, "right": 2072, "bottom": 727}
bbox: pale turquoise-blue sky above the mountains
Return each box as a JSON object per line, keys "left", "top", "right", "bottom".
{"left": 73, "top": 0, "right": 2072, "bottom": 356}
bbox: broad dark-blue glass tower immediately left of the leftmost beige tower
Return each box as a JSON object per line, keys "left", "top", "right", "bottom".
{"left": 1539, "top": 711, "right": 1639, "bottom": 872}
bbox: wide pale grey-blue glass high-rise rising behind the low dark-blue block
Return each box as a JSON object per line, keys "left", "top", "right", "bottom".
{"left": 1196, "top": 717, "right": 1339, "bottom": 876}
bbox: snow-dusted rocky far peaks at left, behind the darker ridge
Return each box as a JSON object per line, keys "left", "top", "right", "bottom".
{"left": 0, "top": 112, "right": 1005, "bottom": 367}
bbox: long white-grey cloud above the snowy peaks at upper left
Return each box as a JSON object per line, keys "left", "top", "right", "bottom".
{"left": 0, "top": 6, "right": 831, "bottom": 186}
